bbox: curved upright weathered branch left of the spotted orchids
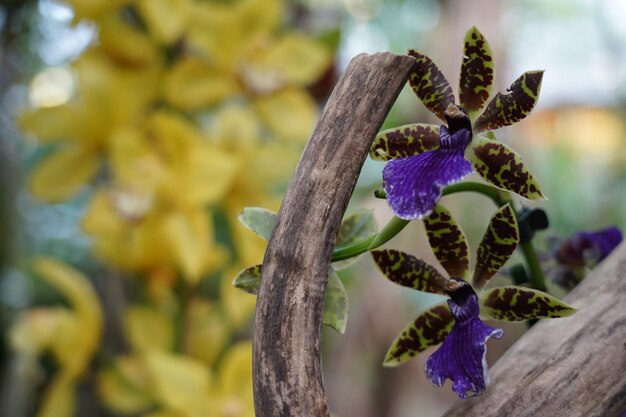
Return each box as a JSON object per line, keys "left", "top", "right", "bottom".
{"left": 253, "top": 53, "right": 414, "bottom": 417}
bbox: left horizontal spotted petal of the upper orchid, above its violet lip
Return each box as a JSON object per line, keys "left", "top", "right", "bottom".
{"left": 370, "top": 123, "right": 440, "bottom": 161}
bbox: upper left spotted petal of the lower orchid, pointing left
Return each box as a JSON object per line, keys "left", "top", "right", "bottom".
{"left": 371, "top": 249, "right": 448, "bottom": 294}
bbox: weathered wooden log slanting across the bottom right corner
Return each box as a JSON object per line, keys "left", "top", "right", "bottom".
{"left": 445, "top": 240, "right": 626, "bottom": 417}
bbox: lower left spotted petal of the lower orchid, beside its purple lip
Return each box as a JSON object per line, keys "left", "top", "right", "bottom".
{"left": 383, "top": 301, "right": 454, "bottom": 366}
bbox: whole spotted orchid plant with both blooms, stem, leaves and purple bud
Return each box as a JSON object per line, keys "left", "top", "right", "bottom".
{"left": 233, "top": 27, "right": 621, "bottom": 399}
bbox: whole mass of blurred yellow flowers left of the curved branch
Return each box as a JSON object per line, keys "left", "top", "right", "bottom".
{"left": 18, "top": 0, "right": 332, "bottom": 417}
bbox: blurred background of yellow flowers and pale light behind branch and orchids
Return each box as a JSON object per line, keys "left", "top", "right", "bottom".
{"left": 0, "top": 0, "right": 626, "bottom": 417}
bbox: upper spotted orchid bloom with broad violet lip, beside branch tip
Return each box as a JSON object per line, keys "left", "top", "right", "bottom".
{"left": 370, "top": 27, "right": 544, "bottom": 220}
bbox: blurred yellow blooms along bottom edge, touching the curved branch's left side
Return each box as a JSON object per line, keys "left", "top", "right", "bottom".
{"left": 98, "top": 324, "right": 254, "bottom": 417}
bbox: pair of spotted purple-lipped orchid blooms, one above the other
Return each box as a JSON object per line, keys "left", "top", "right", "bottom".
{"left": 370, "top": 27, "right": 575, "bottom": 399}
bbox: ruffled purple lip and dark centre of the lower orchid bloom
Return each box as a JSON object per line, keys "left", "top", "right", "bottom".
{"left": 424, "top": 284, "right": 503, "bottom": 399}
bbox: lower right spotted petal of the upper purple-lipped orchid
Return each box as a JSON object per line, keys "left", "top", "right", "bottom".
{"left": 465, "top": 136, "right": 545, "bottom": 200}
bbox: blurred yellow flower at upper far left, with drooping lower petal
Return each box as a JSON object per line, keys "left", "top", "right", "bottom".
{"left": 20, "top": 49, "right": 158, "bottom": 202}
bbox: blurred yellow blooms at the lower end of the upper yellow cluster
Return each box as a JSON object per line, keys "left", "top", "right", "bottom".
{"left": 83, "top": 190, "right": 225, "bottom": 282}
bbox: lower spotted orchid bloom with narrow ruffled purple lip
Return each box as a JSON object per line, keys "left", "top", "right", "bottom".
{"left": 371, "top": 204, "right": 575, "bottom": 398}
